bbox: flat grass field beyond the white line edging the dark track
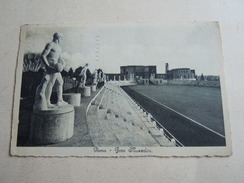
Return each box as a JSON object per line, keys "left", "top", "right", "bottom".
{"left": 130, "top": 85, "right": 224, "bottom": 135}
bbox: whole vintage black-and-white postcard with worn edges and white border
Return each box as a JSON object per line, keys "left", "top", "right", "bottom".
{"left": 11, "top": 22, "right": 232, "bottom": 157}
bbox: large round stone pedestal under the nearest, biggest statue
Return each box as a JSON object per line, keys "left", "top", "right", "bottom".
{"left": 30, "top": 105, "right": 74, "bottom": 145}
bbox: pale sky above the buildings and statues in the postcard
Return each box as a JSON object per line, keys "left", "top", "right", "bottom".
{"left": 24, "top": 22, "right": 222, "bottom": 75}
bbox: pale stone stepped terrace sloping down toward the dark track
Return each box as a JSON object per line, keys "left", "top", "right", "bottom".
{"left": 87, "top": 82, "right": 174, "bottom": 147}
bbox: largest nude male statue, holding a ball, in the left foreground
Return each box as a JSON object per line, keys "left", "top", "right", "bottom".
{"left": 33, "top": 33, "right": 67, "bottom": 110}
